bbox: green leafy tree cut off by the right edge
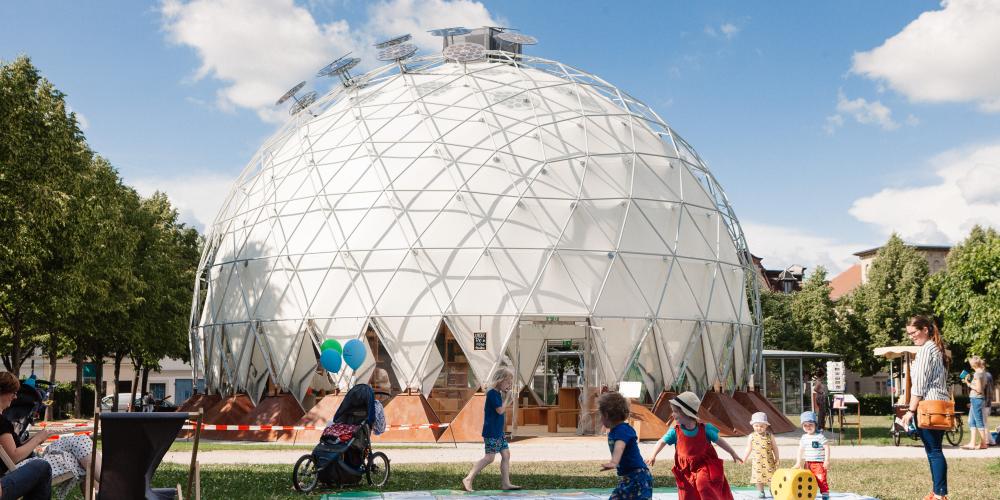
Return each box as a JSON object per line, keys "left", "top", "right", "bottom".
{"left": 934, "top": 226, "right": 1000, "bottom": 359}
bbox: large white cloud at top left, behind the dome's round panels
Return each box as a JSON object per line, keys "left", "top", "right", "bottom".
{"left": 160, "top": 0, "right": 498, "bottom": 121}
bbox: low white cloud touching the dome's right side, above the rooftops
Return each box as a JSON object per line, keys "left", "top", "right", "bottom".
{"left": 740, "top": 221, "right": 874, "bottom": 277}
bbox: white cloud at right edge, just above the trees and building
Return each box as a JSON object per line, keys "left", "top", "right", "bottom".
{"left": 850, "top": 143, "right": 1000, "bottom": 243}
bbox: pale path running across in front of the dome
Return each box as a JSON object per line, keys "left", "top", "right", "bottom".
{"left": 164, "top": 436, "right": 1000, "bottom": 466}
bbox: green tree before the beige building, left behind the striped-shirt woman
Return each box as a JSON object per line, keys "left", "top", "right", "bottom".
{"left": 853, "top": 234, "right": 932, "bottom": 373}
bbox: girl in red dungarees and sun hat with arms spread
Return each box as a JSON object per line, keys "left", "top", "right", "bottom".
{"left": 649, "top": 392, "right": 742, "bottom": 500}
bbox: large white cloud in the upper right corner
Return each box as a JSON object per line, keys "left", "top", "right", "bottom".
{"left": 851, "top": 0, "right": 1000, "bottom": 112}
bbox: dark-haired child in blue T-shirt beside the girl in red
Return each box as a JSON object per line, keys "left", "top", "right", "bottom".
{"left": 597, "top": 392, "right": 653, "bottom": 500}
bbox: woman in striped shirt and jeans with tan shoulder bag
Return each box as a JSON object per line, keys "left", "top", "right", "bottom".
{"left": 903, "top": 316, "right": 951, "bottom": 500}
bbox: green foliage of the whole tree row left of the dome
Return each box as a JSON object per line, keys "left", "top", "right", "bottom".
{"left": 0, "top": 57, "right": 200, "bottom": 412}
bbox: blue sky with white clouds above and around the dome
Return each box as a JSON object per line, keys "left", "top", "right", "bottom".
{"left": 0, "top": 0, "right": 1000, "bottom": 271}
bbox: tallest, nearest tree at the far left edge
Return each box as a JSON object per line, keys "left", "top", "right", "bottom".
{"left": 0, "top": 56, "right": 91, "bottom": 371}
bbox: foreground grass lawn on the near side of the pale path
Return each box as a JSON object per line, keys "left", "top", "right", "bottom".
{"left": 62, "top": 453, "right": 1000, "bottom": 500}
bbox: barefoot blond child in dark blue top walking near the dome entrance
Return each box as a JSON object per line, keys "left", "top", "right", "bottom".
{"left": 462, "top": 368, "right": 521, "bottom": 491}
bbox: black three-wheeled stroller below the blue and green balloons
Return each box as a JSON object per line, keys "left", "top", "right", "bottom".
{"left": 292, "top": 384, "right": 389, "bottom": 493}
